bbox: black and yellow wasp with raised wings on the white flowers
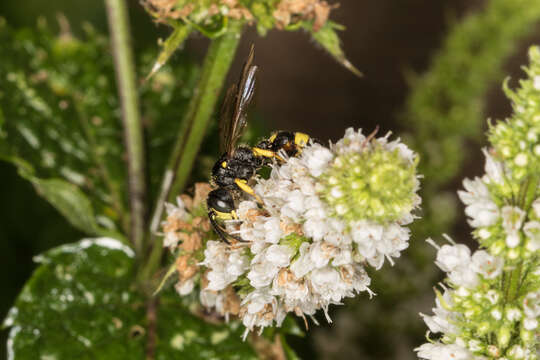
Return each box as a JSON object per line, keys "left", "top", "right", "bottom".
{"left": 206, "top": 46, "right": 310, "bottom": 243}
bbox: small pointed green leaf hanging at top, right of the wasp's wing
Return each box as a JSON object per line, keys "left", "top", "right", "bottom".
{"left": 302, "top": 21, "right": 363, "bottom": 77}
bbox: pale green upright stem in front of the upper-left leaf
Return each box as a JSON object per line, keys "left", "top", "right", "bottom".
{"left": 105, "top": 0, "right": 146, "bottom": 257}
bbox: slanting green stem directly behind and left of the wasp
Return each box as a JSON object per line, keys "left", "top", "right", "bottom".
{"left": 139, "top": 22, "right": 242, "bottom": 286}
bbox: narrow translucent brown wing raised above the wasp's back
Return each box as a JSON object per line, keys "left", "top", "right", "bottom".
{"left": 219, "top": 46, "right": 257, "bottom": 157}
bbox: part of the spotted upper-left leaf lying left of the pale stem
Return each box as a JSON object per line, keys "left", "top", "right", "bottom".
{"left": 0, "top": 24, "right": 125, "bottom": 234}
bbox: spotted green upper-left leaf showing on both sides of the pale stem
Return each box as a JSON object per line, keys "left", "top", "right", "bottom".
{"left": 0, "top": 19, "right": 198, "bottom": 237}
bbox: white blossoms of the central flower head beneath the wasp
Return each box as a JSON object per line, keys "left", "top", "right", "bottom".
{"left": 203, "top": 129, "right": 420, "bottom": 333}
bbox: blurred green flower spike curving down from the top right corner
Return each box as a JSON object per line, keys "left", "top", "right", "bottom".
{"left": 404, "top": 0, "right": 540, "bottom": 239}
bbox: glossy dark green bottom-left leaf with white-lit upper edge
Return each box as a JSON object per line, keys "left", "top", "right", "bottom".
{"left": 4, "top": 238, "right": 255, "bottom": 360}
